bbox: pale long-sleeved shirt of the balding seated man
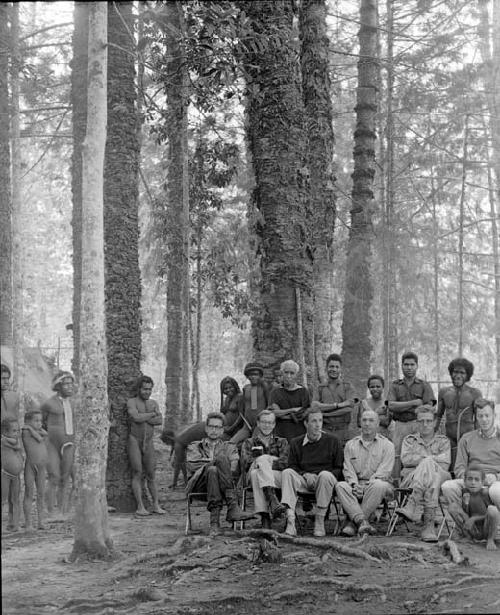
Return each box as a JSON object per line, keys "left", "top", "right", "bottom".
{"left": 344, "top": 434, "right": 394, "bottom": 485}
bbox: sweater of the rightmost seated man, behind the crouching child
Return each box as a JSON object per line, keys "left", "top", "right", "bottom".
{"left": 454, "top": 429, "right": 500, "bottom": 480}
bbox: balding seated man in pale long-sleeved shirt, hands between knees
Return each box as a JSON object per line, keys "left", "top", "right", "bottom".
{"left": 335, "top": 410, "right": 394, "bottom": 536}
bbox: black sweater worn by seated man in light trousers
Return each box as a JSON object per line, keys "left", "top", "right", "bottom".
{"left": 288, "top": 433, "right": 342, "bottom": 478}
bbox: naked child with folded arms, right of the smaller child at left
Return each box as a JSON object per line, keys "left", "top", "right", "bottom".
{"left": 22, "top": 410, "right": 49, "bottom": 531}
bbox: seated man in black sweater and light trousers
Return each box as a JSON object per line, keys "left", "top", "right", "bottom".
{"left": 281, "top": 408, "right": 342, "bottom": 536}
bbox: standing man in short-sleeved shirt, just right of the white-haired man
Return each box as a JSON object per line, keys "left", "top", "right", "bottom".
{"left": 313, "top": 354, "right": 355, "bottom": 445}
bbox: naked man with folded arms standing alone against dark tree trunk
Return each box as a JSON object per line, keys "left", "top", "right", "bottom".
{"left": 127, "top": 376, "right": 165, "bottom": 516}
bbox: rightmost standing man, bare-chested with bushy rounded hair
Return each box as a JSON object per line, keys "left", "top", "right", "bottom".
{"left": 437, "top": 358, "right": 482, "bottom": 468}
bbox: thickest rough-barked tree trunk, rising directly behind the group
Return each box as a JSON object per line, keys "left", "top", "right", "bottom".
{"left": 244, "top": 0, "right": 314, "bottom": 380}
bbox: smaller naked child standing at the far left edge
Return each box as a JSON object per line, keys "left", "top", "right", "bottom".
{"left": 0, "top": 418, "right": 24, "bottom": 532}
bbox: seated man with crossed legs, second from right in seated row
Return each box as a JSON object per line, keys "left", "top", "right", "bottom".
{"left": 396, "top": 406, "right": 451, "bottom": 542}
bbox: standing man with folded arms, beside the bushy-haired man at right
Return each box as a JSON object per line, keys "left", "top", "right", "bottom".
{"left": 387, "top": 352, "right": 436, "bottom": 477}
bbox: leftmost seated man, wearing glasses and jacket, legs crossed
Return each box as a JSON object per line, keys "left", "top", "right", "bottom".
{"left": 186, "top": 412, "right": 253, "bottom": 534}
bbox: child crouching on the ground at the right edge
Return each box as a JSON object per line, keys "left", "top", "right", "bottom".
{"left": 448, "top": 465, "right": 500, "bottom": 551}
